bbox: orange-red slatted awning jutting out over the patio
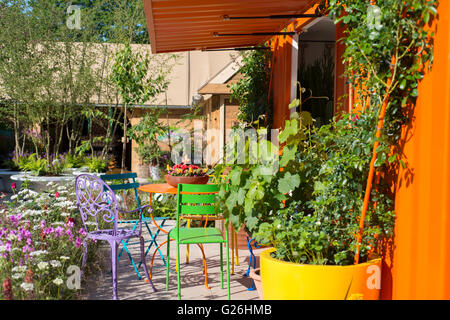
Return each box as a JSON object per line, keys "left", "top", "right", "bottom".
{"left": 143, "top": 0, "right": 319, "bottom": 53}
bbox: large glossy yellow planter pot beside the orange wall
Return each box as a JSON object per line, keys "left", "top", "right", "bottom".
{"left": 260, "top": 248, "right": 381, "bottom": 300}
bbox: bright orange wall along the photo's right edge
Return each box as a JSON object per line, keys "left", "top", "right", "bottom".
{"left": 382, "top": 1, "right": 450, "bottom": 299}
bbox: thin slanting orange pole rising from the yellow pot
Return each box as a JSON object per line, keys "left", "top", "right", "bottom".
{"left": 355, "top": 56, "right": 396, "bottom": 264}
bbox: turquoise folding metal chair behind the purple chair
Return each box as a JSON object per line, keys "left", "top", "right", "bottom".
{"left": 100, "top": 172, "right": 167, "bottom": 280}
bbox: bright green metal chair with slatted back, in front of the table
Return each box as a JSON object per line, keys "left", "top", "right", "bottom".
{"left": 166, "top": 184, "right": 230, "bottom": 300}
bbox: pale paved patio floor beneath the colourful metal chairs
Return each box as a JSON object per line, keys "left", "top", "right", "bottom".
{"left": 83, "top": 221, "right": 263, "bottom": 300}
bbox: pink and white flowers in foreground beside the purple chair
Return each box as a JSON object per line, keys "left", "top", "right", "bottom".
{"left": 0, "top": 183, "right": 99, "bottom": 299}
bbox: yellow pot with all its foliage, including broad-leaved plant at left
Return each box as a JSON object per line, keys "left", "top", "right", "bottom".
{"left": 216, "top": 93, "right": 394, "bottom": 299}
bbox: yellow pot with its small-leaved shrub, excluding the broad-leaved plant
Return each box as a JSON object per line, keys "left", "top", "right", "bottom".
{"left": 255, "top": 109, "right": 394, "bottom": 300}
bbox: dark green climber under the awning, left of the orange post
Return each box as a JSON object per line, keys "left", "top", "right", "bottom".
{"left": 230, "top": 50, "right": 272, "bottom": 126}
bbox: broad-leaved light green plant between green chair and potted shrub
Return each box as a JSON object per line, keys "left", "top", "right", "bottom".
{"left": 214, "top": 112, "right": 312, "bottom": 232}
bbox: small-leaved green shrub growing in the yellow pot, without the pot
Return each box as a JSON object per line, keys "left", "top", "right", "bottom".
{"left": 256, "top": 110, "right": 394, "bottom": 265}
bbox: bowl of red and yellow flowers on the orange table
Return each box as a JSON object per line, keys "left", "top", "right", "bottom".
{"left": 165, "top": 163, "right": 209, "bottom": 188}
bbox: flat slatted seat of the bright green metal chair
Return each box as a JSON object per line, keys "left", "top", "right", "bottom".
{"left": 169, "top": 228, "right": 226, "bottom": 244}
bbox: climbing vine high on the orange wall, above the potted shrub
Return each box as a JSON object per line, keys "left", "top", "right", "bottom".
{"left": 318, "top": 0, "right": 438, "bottom": 167}
